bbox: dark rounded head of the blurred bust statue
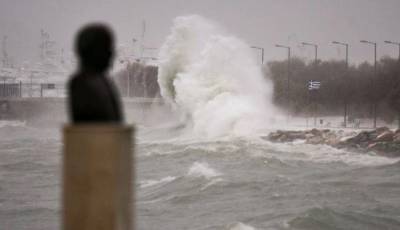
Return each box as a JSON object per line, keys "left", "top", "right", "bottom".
{"left": 75, "top": 24, "right": 114, "bottom": 73}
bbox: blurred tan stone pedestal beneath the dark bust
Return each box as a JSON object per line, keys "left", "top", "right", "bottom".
{"left": 63, "top": 124, "right": 134, "bottom": 230}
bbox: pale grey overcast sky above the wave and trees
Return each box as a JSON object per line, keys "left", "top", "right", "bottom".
{"left": 0, "top": 0, "right": 400, "bottom": 64}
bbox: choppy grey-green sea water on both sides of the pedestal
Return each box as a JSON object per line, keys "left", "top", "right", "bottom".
{"left": 0, "top": 123, "right": 400, "bottom": 230}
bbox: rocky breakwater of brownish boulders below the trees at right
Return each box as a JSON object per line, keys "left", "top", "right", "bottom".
{"left": 263, "top": 127, "right": 400, "bottom": 157}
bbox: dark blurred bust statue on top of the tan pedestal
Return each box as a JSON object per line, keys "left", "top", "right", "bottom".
{"left": 68, "top": 24, "right": 123, "bottom": 123}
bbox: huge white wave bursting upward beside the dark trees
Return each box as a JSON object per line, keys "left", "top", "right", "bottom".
{"left": 158, "top": 15, "right": 275, "bottom": 137}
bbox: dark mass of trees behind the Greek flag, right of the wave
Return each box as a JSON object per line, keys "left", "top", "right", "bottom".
{"left": 266, "top": 57, "right": 400, "bottom": 121}
